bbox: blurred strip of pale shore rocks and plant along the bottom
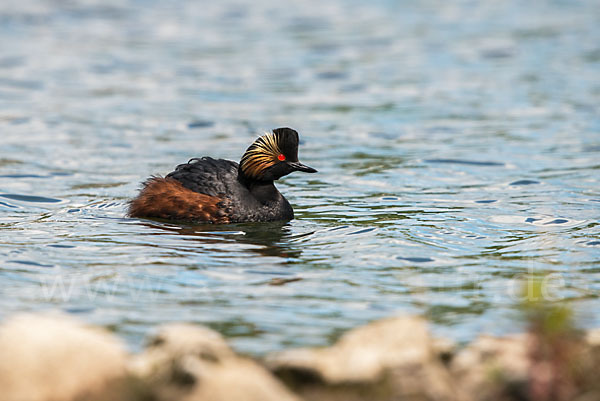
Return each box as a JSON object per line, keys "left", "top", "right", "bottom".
{"left": 0, "top": 305, "right": 600, "bottom": 401}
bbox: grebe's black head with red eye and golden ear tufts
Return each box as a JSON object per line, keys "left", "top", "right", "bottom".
{"left": 239, "top": 128, "right": 317, "bottom": 181}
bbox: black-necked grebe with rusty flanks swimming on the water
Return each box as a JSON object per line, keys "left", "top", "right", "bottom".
{"left": 128, "top": 128, "right": 317, "bottom": 224}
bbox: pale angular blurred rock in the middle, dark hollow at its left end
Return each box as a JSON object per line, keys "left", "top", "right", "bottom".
{"left": 266, "top": 317, "right": 458, "bottom": 401}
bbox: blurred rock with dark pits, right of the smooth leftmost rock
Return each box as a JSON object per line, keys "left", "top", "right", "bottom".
{"left": 130, "top": 324, "right": 299, "bottom": 401}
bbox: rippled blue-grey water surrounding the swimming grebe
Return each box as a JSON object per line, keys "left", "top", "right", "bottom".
{"left": 0, "top": 0, "right": 600, "bottom": 353}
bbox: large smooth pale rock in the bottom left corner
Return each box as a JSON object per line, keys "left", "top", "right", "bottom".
{"left": 0, "top": 314, "right": 126, "bottom": 401}
